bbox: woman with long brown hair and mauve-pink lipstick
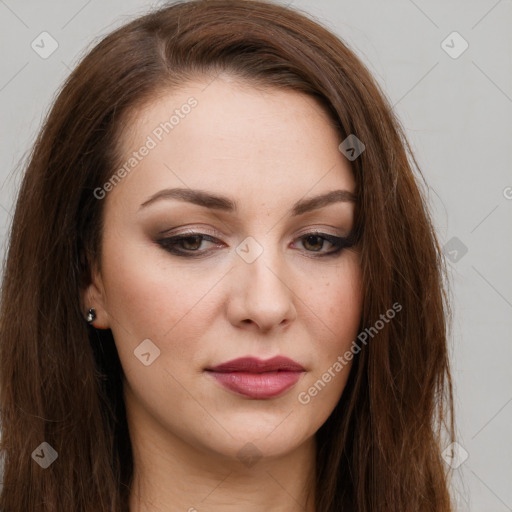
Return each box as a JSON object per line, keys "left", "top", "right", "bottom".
{"left": 0, "top": 0, "right": 454, "bottom": 512}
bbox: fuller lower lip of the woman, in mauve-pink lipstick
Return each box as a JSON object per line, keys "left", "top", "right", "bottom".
{"left": 208, "top": 370, "right": 304, "bottom": 399}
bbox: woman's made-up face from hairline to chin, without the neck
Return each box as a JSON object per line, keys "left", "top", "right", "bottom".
{"left": 84, "top": 77, "right": 362, "bottom": 459}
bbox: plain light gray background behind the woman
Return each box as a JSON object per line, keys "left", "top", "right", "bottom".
{"left": 0, "top": 0, "right": 512, "bottom": 512}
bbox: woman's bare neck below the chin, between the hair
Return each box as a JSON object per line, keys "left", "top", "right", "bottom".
{"left": 129, "top": 398, "right": 316, "bottom": 512}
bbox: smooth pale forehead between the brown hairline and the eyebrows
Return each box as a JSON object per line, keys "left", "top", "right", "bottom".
{"left": 108, "top": 77, "right": 355, "bottom": 212}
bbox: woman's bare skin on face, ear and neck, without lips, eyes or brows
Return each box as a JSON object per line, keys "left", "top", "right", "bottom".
{"left": 84, "top": 75, "right": 362, "bottom": 512}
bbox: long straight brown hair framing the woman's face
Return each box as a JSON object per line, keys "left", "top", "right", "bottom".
{"left": 0, "top": 0, "right": 454, "bottom": 512}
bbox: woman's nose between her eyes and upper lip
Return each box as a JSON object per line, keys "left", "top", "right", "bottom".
{"left": 228, "top": 242, "right": 297, "bottom": 332}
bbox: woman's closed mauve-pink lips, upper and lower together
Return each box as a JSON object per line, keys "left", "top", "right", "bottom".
{"left": 205, "top": 356, "right": 306, "bottom": 400}
